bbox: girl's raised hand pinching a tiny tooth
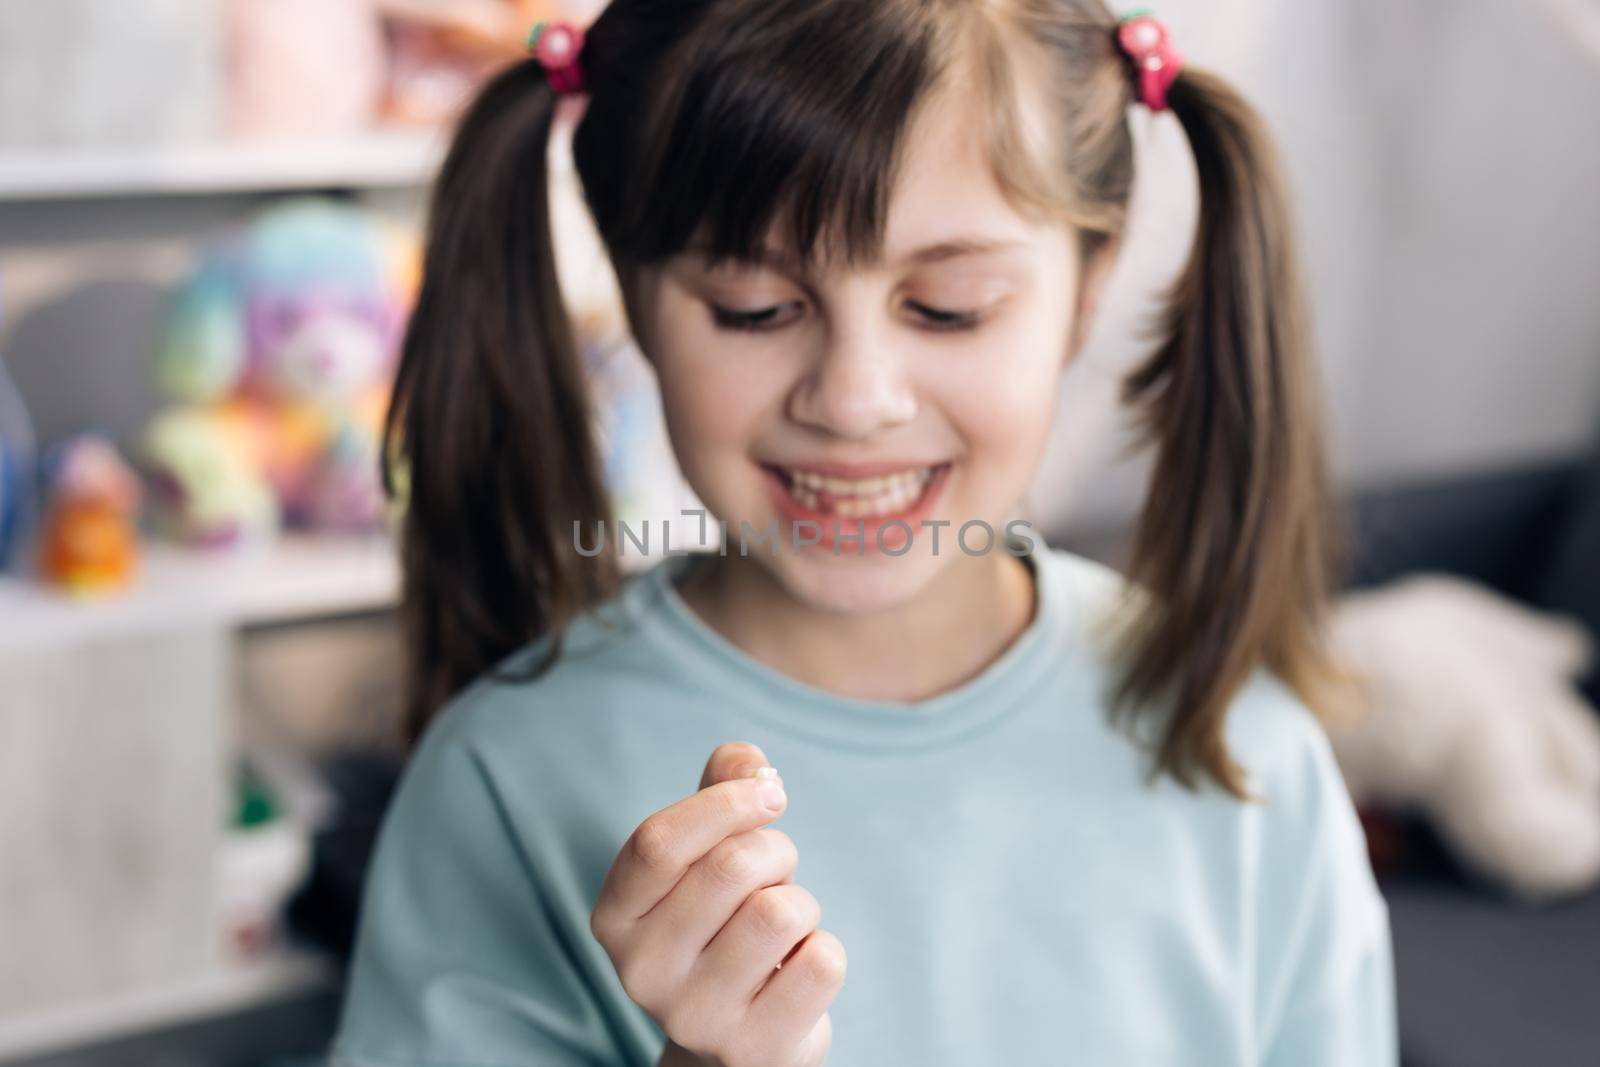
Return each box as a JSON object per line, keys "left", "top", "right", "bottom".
{"left": 589, "top": 742, "right": 845, "bottom": 1067}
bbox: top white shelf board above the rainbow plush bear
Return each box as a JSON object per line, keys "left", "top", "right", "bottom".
{"left": 0, "top": 130, "right": 446, "bottom": 202}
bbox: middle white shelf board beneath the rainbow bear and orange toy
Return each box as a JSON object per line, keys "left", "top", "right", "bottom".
{"left": 0, "top": 536, "right": 400, "bottom": 649}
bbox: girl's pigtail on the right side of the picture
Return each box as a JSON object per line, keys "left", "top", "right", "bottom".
{"left": 1117, "top": 70, "right": 1346, "bottom": 798}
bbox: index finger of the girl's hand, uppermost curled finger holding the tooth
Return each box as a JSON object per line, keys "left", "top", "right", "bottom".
{"left": 595, "top": 767, "right": 789, "bottom": 926}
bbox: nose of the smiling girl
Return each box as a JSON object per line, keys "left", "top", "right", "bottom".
{"left": 789, "top": 319, "right": 917, "bottom": 438}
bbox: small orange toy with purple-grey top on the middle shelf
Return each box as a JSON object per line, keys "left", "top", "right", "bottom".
{"left": 38, "top": 435, "right": 141, "bottom": 597}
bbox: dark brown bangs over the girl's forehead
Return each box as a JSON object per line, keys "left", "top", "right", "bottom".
{"left": 611, "top": 0, "right": 946, "bottom": 275}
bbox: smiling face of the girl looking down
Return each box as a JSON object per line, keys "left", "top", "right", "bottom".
{"left": 624, "top": 83, "right": 1100, "bottom": 613}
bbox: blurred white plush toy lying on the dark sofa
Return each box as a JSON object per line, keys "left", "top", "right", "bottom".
{"left": 1328, "top": 574, "right": 1600, "bottom": 901}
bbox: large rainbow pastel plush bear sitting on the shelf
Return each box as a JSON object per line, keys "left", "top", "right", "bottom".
{"left": 146, "top": 198, "right": 418, "bottom": 545}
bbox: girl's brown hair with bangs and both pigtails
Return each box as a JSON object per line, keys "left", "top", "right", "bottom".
{"left": 386, "top": 0, "right": 1336, "bottom": 797}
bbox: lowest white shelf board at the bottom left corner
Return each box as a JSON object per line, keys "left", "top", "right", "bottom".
{"left": 0, "top": 949, "right": 338, "bottom": 1061}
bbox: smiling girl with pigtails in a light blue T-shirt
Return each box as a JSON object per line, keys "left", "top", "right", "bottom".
{"left": 336, "top": 0, "right": 1397, "bottom": 1067}
